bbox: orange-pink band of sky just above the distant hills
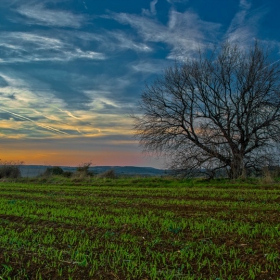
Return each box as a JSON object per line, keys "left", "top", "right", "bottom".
{"left": 0, "top": 136, "right": 164, "bottom": 168}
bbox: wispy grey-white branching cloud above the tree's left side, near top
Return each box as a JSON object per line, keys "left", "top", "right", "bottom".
{"left": 111, "top": 10, "right": 220, "bottom": 59}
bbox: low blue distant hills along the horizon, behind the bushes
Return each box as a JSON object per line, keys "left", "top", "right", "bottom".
{"left": 20, "top": 165, "right": 165, "bottom": 177}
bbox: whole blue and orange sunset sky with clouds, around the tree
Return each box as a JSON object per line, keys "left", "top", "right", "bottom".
{"left": 0, "top": 0, "right": 280, "bottom": 168}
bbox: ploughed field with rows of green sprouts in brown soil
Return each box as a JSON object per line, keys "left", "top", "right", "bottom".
{"left": 0, "top": 177, "right": 280, "bottom": 280}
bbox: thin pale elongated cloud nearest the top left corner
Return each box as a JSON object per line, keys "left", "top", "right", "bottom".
{"left": 16, "top": 3, "right": 86, "bottom": 28}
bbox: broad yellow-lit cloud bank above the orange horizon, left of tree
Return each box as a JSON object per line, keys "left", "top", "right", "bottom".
{"left": 0, "top": 71, "right": 136, "bottom": 139}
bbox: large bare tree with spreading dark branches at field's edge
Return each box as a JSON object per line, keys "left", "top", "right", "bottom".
{"left": 133, "top": 43, "right": 280, "bottom": 178}
